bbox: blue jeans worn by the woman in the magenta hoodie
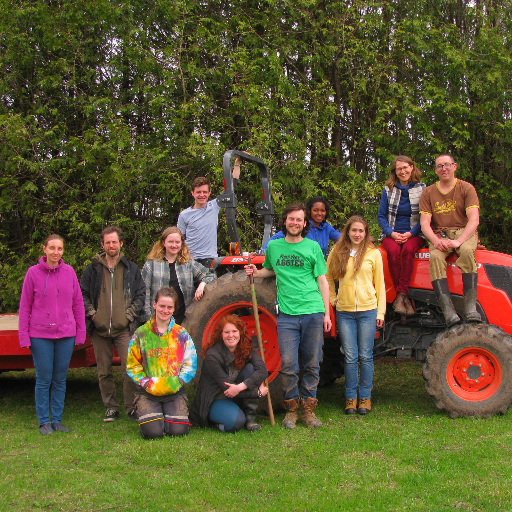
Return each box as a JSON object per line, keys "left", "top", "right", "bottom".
{"left": 30, "top": 336, "right": 75, "bottom": 425}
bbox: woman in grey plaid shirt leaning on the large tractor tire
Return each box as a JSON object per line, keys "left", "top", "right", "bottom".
{"left": 140, "top": 226, "right": 216, "bottom": 324}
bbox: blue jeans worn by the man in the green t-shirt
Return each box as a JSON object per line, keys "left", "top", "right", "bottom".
{"left": 277, "top": 313, "right": 324, "bottom": 400}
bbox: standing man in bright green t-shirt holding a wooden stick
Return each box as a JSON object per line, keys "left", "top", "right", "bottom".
{"left": 245, "top": 203, "right": 331, "bottom": 428}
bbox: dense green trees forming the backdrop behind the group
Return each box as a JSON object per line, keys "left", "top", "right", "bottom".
{"left": 0, "top": 0, "right": 512, "bottom": 311}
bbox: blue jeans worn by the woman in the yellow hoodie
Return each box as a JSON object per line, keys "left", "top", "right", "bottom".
{"left": 336, "top": 309, "right": 377, "bottom": 399}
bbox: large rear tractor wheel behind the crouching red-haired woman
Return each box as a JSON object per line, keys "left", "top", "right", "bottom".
{"left": 183, "top": 270, "right": 282, "bottom": 413}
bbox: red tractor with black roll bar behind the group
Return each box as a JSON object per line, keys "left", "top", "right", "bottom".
{"left": 184, "top": 151, "right": 512, "bottom": 418}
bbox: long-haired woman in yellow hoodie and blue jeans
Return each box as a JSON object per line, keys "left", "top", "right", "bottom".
{"left": 327, "top": 215, "right": 386, "bottom": 414}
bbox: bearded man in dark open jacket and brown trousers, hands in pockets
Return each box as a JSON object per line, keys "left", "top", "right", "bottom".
{"left": 80, "top": 226, "right": 146, "bottom": 421}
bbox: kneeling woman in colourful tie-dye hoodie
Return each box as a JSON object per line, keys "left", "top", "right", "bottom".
{"left": 126, "top": 286, "right": 197, "bottom": 439}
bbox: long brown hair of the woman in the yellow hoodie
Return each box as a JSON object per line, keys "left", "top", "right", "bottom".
{"left": 329, "top": 215, "right": 375, "bottom": 281}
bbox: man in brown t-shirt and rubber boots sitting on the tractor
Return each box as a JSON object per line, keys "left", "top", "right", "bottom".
{"left": 420, "top": 154, "right": 481, "bottom": 327}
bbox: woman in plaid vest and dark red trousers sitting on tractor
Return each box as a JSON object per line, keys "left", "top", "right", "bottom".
{"left": 378, "top": 155, "right": 425, "bottom": 316}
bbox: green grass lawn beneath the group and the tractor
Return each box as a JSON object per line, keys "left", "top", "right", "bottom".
{"left": 0, "top": 358, "right": 512, "bottom": 512}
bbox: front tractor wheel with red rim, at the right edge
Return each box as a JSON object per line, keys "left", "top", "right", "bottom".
{"left": 423, "top": 324, "right": 512, "bottom": 418}
